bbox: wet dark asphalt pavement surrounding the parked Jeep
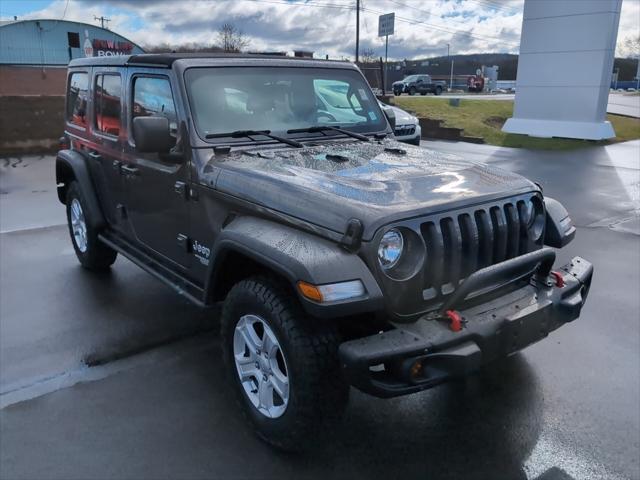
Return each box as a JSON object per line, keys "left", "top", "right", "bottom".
{"left": 0, "top": 142, "right": 640, "bottom": 480}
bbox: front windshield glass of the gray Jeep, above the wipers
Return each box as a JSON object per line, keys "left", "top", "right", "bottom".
{"left": 185, "top": 67, "right": 387, "bottom": 138}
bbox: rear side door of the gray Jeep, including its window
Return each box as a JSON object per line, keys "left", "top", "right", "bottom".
{"left": 86, "top": 69, "right": 124, "bottom": 230}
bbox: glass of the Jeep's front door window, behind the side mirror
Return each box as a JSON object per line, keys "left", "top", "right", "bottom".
{"left": 131, "top": 77, "right": 178, "bottom": 137}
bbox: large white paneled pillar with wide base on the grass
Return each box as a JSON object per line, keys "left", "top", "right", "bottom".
{"left": 502, "top": 0, "right": 622, "bottom": 140}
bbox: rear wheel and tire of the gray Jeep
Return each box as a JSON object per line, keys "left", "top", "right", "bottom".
{"left": 66, "top": 181, "right": 118, "bottom": 270}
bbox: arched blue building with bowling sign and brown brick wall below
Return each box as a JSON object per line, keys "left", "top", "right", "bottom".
{"left": 0, "top": 19, "right": 144, "bottom": 155}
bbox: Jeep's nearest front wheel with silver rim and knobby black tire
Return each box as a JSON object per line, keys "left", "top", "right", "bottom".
{"left": 221, "top": 277, "right": 348, "bottom": 451}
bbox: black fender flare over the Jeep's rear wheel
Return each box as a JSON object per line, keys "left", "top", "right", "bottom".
{"left": 56, "top": 150, "right": 106, "bottom": 229}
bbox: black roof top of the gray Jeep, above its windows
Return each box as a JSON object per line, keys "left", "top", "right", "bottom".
{"left": 69, "top": 53, "right": 354, "bottom": 68}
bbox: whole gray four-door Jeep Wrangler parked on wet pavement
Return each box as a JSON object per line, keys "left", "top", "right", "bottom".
{"left": 56, "top": 54, "right": 593, "bottom": 449}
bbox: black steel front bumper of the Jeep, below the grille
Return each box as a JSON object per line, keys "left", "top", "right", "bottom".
{"left": 339, "top": 252, "right": 593, "bottom": 397}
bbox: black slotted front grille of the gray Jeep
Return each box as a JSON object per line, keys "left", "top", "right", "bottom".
{"left": 420, "top": 200, "right": 540, "bottom": 300}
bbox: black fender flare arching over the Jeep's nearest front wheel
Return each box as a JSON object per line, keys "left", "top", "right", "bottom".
{"left": 205, "top": 217, "right": 384, "bottom": 318}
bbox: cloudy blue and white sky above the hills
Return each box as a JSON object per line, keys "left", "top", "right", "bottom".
{"left": 0, "top": 0, "right": 640, "bottom": 59}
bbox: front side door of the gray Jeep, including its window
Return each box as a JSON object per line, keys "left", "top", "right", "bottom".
{"left": 122, "top": 73, "right": 190, "bottom": 269}
